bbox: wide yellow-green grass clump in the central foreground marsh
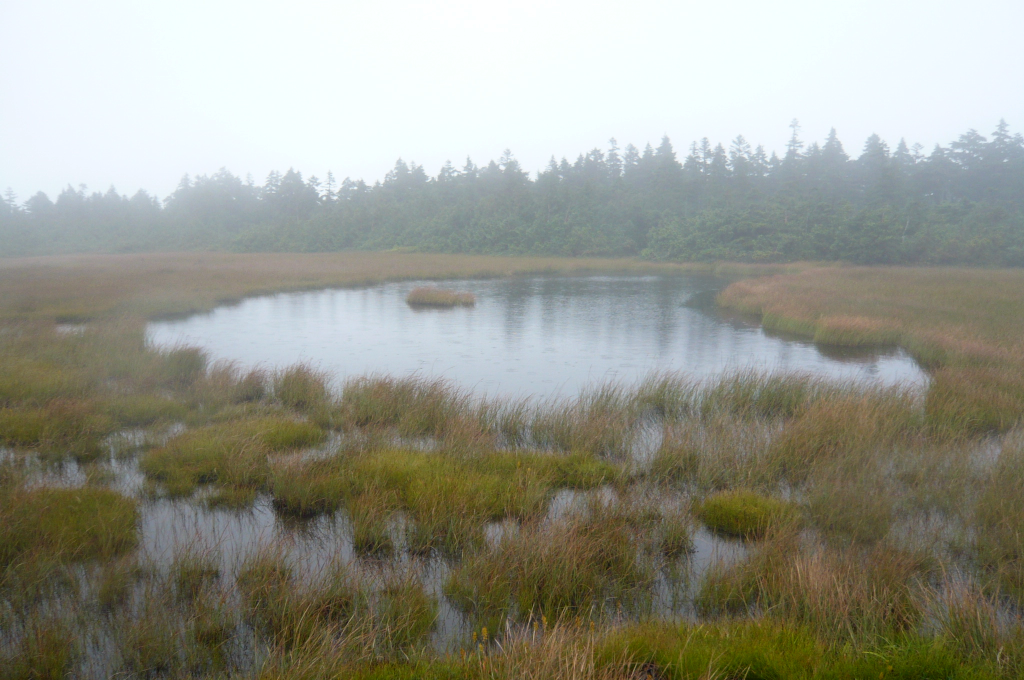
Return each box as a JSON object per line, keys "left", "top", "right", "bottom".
{"left": 269, "top": 449, "right": 621, "bottom": 555}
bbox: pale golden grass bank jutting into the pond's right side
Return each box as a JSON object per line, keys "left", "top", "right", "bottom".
{"left": 719, "top": 266, "right": 1024, "bottom": 364}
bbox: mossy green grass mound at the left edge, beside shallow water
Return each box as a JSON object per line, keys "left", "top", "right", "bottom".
{"left": 0, "top": 487, "right": 138, "bottom": 565}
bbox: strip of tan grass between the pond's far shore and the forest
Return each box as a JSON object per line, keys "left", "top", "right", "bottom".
{"left": 0, "top": 252, "right": 713, "bottom": 321}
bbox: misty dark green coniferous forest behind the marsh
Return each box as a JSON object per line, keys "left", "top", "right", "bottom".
{"left": 0, "top": 121, "right": 1024, "bottom": 266}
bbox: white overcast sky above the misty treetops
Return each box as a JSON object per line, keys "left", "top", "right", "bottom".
{"left": 0, "top": 0, "right": 1024, "bottom": 201}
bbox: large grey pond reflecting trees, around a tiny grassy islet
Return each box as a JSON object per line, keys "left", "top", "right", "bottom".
{"left": 148, "top": 275, "right": 927, "bottom": 397}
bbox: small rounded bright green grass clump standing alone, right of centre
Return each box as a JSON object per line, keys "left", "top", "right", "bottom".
{"left": 697, "top": 490, "right": 800, "bottom": 539}
